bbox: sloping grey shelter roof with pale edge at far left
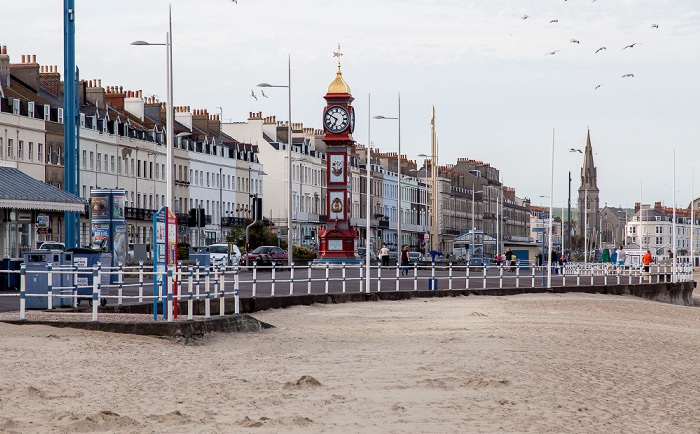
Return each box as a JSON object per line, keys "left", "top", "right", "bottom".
{"left": 0, "top": 167, "right": 87, "bottom": 212}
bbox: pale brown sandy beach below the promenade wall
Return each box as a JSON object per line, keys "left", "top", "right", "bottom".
{"left": 0, "top": 291, "right": 700, "bottom": 434}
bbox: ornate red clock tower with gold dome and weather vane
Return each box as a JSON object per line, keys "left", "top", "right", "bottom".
{"left": 316, "top": 45, "right": 360, "bottom": 263}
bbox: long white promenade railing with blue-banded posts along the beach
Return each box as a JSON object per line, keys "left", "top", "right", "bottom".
{"left": 0, "top": 262, "right": 693, "bottom": 321}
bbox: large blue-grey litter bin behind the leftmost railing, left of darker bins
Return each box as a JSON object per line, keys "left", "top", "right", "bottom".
{"left": 24, "top": 250, "right": 73, "bottom": 309}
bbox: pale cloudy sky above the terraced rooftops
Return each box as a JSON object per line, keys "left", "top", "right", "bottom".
{"left": 0, "top": 0, "right": 700, "bottom": 207}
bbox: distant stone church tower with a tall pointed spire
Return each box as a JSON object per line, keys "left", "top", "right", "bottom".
{"left": 576, "top": 130, "right": 600, "bottom": 248}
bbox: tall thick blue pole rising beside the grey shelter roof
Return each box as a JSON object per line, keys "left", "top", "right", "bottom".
{"left": 63, "top": 0, "right": 77, "bottom": 248}
